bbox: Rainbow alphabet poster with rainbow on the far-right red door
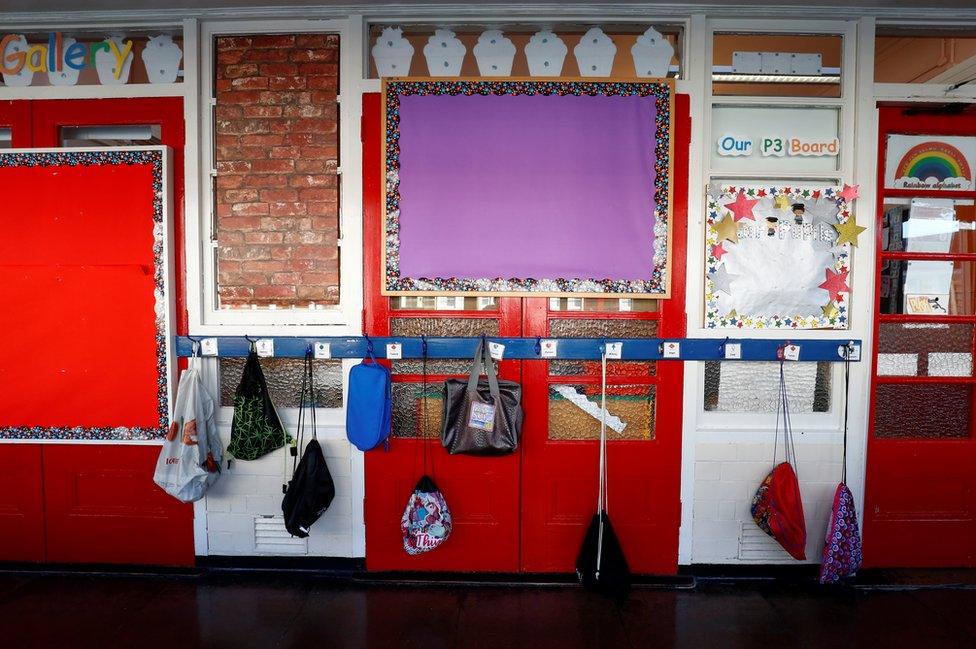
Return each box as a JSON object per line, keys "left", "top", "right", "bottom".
{"left": 885, "top": 135, "right": 976, "bottom": 191}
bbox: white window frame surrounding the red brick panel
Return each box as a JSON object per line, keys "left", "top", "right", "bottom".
{"left": 186, "top": 18, "right": 363, "bottom": 336}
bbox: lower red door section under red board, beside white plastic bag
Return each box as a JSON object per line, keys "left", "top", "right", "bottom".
{"left": 44, "top": 444, "right": 194, "bottom": 566}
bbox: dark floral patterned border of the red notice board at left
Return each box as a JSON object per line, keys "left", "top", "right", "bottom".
{"left": 0, "top": 150, "right": 169, "bottom": 441}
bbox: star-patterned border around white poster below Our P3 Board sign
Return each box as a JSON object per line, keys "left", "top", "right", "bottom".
{"left": 705, "top": 185, "right": 863, "bottom": 329}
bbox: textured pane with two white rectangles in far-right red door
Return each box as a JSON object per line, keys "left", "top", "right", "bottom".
{"left": 878, "top": 322, "right": 973, "bottom": 376}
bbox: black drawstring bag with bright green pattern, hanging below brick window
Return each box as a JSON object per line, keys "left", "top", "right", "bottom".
{"left": 227, "top": 347, "right": 291, "bottom": 460}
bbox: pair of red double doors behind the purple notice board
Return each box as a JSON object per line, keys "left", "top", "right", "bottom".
{"left": 363, "top": 95, "right": 689, "bottom": 573}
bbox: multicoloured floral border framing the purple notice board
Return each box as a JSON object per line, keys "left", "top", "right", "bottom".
{"left": 384, "top": 80, "right": 672, "bottom": 295}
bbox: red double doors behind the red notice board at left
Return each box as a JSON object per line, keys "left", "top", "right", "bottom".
{"left": 0, "top": 98, "right": 194, "bottom": 565}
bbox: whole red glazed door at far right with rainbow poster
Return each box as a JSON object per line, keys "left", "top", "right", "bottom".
{"left": 864, "top": 108, "right": 976, "bottom": 567}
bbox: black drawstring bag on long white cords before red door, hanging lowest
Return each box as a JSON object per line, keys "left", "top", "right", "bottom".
{"left": 576, "top": 351, "right": 630, "bottom": 597}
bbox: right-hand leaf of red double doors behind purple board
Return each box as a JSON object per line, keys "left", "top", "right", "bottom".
{"left": 522, "top": 95, "right": 690, "bottom": 574}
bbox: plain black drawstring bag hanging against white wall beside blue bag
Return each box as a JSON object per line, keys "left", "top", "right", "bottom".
{"left": 281, "top": 350, "right": 335, "bottom": 538}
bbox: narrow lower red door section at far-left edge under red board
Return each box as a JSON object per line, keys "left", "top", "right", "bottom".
{"left": 0, "top": 444, "right": 44, "bottom": 562}
